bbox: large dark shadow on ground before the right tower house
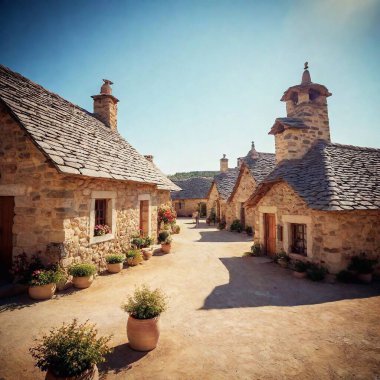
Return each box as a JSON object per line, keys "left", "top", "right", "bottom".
{"left": 201, "top": 257, "right": 380, "bottom": 310}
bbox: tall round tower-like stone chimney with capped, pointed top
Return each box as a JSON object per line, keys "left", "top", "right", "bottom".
{"left": 269, "top": 62, "right": 331, "bottom": 163}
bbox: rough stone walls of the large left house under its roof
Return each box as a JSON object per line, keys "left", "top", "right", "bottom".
{"left": 0, "top": 107, "right": 170, "bottom": 265}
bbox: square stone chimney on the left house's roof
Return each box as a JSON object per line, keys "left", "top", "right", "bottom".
{"left": 92, "top": 79, "right": 119, "bottom": 131}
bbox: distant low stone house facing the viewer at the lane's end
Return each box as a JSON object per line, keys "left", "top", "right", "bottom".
{"left": 170, "top": 177, "right": 212, "bottom": 217}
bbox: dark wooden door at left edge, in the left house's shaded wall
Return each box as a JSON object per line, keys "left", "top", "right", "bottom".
{"left": 0, "top": 197, "right": 15, "bottom": 279}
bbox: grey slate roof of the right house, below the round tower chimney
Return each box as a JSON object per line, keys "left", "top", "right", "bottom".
{"left": 247, "top": 141, "right": 380, "bottom": 211}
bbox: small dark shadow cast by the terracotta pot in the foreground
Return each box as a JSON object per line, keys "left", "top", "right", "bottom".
{"left": 98, "top": 343, "right": 148, "bottom": 379}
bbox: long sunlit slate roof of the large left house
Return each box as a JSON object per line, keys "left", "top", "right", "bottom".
{"left": 0, "top": 65, "right": 178, "bottom": 190}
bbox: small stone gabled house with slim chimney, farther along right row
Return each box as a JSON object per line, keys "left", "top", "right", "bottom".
{"left": 207, "top": 154, "right": 239, "bottom": 221}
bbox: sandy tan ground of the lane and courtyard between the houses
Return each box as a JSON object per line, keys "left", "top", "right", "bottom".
{"left": 0, "top": 219, "right": 380, "bottom": 380}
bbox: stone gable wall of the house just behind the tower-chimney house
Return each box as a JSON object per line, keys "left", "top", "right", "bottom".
{"left": 226, "top": 166, "right": 256, "bottom": 228}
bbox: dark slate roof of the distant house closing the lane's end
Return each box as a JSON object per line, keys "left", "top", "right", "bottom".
{"left": 171, "top": 177, "right": 213, "bottom": 200}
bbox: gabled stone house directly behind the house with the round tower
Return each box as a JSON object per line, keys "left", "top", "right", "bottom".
{"left": 226, "top": 142, "right": 276, "bottom": 228}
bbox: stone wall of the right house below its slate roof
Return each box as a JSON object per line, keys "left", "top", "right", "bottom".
{"left": 251, "top": 183, "right": 380, "bottom": 273}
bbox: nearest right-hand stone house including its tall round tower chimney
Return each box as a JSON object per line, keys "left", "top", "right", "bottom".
{"left": 246, "top": 67, "right": 380, "bottom": 273}
